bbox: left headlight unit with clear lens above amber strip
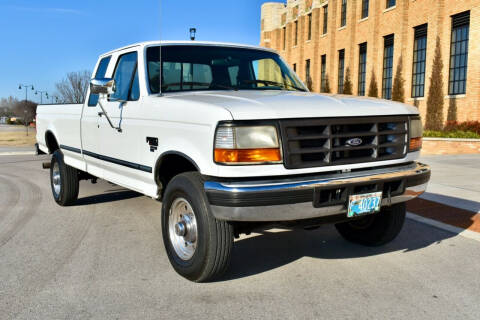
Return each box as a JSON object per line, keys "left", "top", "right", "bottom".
{"left": 214, "top": 126, "right": 282, "bottom": 164}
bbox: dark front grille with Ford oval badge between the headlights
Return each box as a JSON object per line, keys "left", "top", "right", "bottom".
{"left": 280, "top": 116, "right": 408, "bottom": 169}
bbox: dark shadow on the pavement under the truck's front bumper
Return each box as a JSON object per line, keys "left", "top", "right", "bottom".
{"left": 218, "top": 219, "right": 470, "bottom": 282}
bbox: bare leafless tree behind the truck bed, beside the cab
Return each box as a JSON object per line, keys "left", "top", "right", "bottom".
{"left": 55, "top": 70, "right": 90, "bottom": 103}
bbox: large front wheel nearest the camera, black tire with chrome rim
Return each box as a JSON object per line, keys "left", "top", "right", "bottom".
{"left": 162, "top": 172, "right": 233, "bottom": 282}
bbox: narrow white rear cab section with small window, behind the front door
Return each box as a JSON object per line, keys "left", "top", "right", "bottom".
{"left": 81, "top": 56, "right": 112, "bottom": 178}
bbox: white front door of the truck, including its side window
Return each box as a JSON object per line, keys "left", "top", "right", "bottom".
{"left": 100, "top": 51, "right": 152, "bottom": 193}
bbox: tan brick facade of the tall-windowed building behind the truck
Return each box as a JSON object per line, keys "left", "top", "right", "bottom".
{"left": 261, "top": 0, "right": 480, "bottom": 121}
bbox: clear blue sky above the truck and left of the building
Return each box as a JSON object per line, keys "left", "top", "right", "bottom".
{"left": 0, "top": 0, "right": 284, "bottom": 100}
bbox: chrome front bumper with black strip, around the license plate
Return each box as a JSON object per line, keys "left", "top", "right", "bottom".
{"left": 204, "top": 162, "right": 430, "bottom": 222}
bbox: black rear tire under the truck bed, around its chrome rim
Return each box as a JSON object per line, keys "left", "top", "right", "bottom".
{"left": 50, "top": 150, "right": 79, "bottom": 207}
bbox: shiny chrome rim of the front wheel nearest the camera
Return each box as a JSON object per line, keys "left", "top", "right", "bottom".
{"left": 168, "top": 198, "right": 198, "bottom": 261}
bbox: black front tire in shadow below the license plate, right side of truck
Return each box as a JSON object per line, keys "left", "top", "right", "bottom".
{"left": 335, "top": 203, "right": 407, "bottom": 246}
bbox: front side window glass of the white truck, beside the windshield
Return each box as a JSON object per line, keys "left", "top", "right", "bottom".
{"left": 110, "top": 52, "right": 140, "bottom": 101}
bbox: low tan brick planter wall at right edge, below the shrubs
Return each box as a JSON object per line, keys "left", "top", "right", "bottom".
{"left": 422, "top": 138, "right": 480, "bottom": 155}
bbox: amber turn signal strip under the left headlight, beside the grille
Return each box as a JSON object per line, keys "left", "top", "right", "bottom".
{"left": 215, "top": 148, "right": 282, "bottom": 164}
